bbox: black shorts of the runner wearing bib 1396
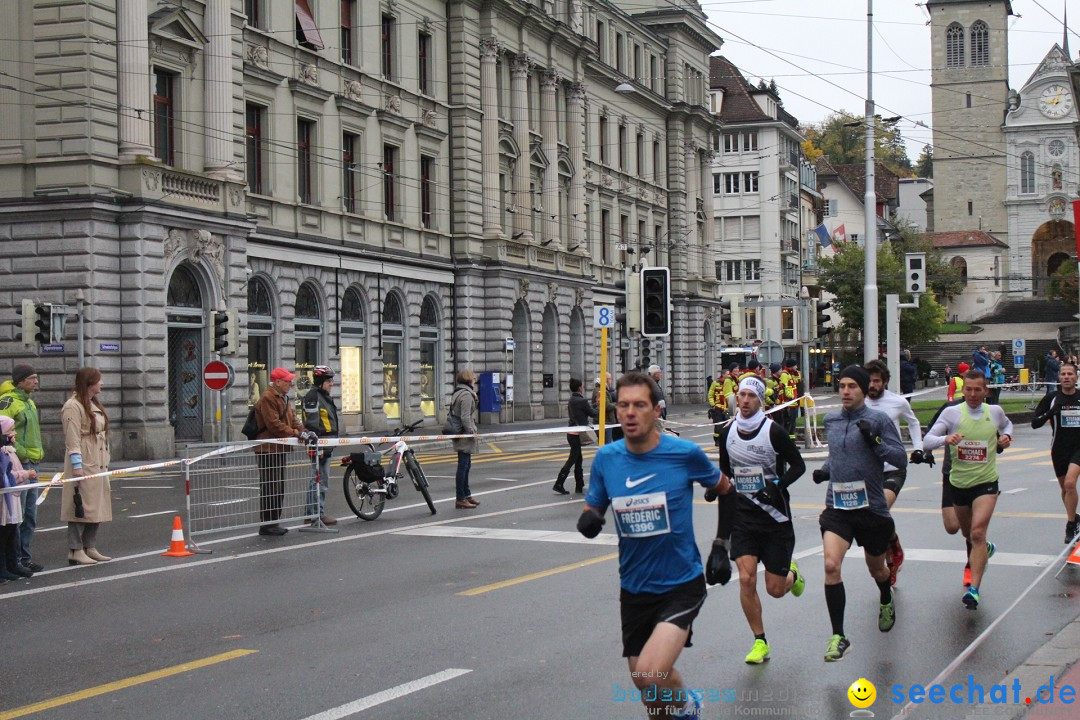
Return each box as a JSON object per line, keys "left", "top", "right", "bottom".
{"left": 619, "top": 574, "right": 707, "bottom": 657}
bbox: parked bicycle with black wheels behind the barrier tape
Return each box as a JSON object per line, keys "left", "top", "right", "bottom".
{"left": 341, "top": 420, "right": 435, "bottom": 520}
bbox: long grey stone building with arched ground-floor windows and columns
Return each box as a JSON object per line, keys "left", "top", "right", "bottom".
{"left": 0, "top": 0, "right": 720, "bottom": 458}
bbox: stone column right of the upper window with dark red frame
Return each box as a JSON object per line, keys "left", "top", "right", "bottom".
{"left": 203, "top": 0, "right": 242, "bottom": 180}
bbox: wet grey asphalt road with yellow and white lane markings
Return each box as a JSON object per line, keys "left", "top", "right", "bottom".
{"left": 0, "top": 414, "right": 1080, "bottom": 720}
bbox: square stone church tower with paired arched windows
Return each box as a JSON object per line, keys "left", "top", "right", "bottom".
{"left": 927, "top": 0, "right": 1014, "bottom": 235}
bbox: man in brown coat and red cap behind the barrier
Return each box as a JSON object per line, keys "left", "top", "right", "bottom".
{"left": 255, "top": 367, "right": 311, "bottom": 535}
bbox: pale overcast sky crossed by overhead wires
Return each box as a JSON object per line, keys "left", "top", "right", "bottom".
{"left": 701, "top": 0, "right": 1080, "bottom": 157}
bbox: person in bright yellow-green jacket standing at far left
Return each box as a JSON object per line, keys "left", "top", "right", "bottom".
{"left": 0, "top": 364, "right": 45, "bottom": 572}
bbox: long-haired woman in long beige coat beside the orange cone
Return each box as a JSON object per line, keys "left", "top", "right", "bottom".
{"left": 60, "top": 367, "right": 112, "bottom": 565}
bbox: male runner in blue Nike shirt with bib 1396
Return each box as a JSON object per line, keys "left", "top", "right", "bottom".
{"left": 578, "top": 372, "right": 720, "bottom": 717}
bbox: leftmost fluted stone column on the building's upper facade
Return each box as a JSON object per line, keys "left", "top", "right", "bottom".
{"left": 117, "top": 0, "right": 153, "bottom": 160}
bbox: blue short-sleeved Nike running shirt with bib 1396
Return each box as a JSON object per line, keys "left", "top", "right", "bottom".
{"left": 585, "top": 435, "right": 720, "bottom": 593}
